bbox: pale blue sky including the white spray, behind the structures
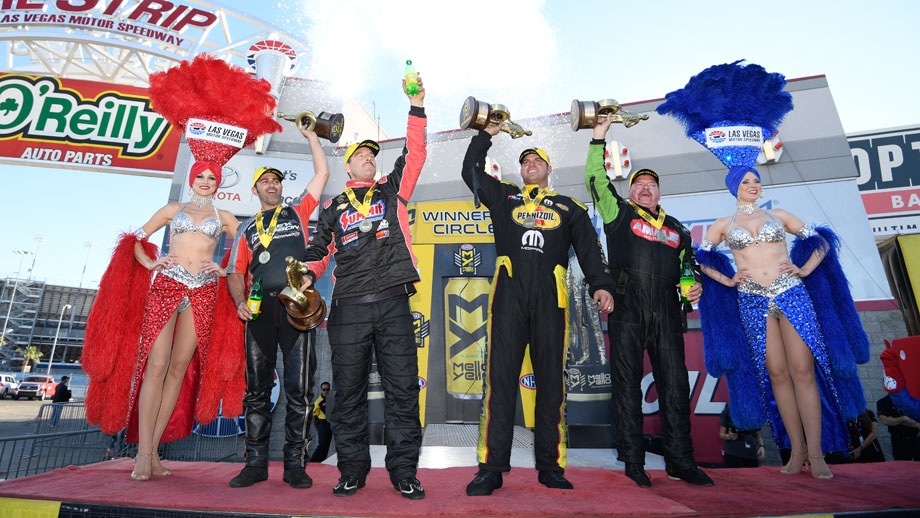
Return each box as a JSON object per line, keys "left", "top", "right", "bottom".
{"left": 0, "top": 0, "right": 920, "bottom": 287}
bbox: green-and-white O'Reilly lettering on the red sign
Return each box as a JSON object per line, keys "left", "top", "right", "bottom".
{"left": 0, "top": 75, "right": 171, "bottom": 158}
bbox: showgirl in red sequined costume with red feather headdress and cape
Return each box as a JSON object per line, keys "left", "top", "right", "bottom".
{"left": 83, "top": 56, "right": 280, "bottom": 481}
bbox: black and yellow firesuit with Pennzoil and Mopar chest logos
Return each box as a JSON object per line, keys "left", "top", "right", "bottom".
{"left": 462, "top": 131, "right": 613, "bottom": 480}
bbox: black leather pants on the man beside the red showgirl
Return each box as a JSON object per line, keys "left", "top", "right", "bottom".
{"left": 243, "top": 294, "right": 316, "bottom": 469}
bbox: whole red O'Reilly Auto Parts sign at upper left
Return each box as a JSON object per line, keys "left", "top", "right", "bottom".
{"left": 0, "top": 74, "right": 180, "bottom": 177}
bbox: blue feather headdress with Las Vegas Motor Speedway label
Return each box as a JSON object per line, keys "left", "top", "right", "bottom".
{"left": 657, "top": 60, "right": 792, "bottom": 168}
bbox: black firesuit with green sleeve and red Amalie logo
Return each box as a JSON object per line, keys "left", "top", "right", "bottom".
{"left": 585, "top": 139, "right": 696, "bottom": 475}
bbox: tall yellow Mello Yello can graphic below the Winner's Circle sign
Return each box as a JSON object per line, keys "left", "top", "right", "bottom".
{"left": 444, "top": 277, "right": 491, "bottom": 399}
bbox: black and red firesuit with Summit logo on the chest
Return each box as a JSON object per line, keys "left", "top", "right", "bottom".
{"left": 304, "top": 106, "right": 427, "bottom": 487}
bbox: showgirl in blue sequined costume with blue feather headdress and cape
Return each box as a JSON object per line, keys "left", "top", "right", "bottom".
{"left": 658, "top": 62, "right": 869, "bottom": 484}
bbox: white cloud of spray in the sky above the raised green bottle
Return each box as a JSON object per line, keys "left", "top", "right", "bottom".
{"left": 302, "top": 0, "right": 552, "bottom": 131}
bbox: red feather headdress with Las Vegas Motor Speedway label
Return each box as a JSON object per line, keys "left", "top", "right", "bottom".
{"left": 148, "top": 54, "right": 281, "bottom": 173}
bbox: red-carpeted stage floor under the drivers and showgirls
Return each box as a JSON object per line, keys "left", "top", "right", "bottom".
{"left": 0, "top": 459, "right": 920, "bottom": 517}
